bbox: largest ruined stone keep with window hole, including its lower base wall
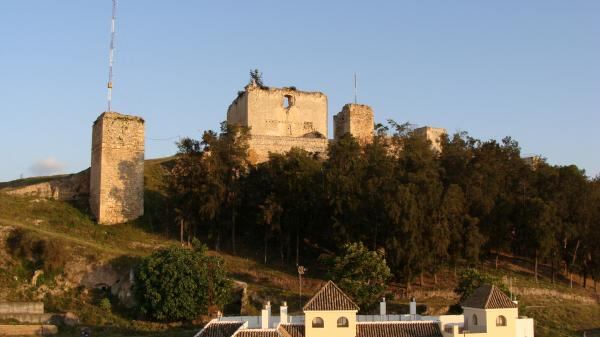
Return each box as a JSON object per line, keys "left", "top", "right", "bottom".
{"left": 227, "top": 84, "right": 329, "bottom": 163}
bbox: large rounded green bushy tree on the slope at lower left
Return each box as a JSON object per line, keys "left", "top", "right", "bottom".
{"left": 135, "top": 241, "right": 231, "bottom": 321}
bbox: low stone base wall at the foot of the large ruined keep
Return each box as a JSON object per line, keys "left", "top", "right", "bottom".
{"left": 248, "top": 135, "right": 329, "bottom": 163}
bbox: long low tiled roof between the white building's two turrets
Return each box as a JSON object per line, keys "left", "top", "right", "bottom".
{"left": 356, "top": 322, "right": 442, "bottom": 337}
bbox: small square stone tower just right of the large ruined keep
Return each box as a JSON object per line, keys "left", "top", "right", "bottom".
{"left": 333, "top": 104, "right": 375, "bottom": 144}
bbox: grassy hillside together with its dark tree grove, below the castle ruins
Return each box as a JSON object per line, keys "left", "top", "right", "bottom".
{"left": 0, "top": 120, "right": 600, "bottom": 336}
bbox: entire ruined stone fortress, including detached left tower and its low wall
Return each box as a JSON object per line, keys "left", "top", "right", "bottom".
{"left": 2, "top": 82, "right": 446, "bottom": 225}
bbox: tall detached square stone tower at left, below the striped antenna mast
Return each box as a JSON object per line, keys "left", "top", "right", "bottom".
{"left": 90, "top": 112, "right": 144, "bottom": 225}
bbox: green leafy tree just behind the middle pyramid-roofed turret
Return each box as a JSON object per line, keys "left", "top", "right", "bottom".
{"left": 330, "top": 242, "right": 392, "bottom": 310}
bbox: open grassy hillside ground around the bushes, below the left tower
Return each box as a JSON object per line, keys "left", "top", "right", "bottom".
{"left": 0, "top": 158, "right": 600, "bottom": 337}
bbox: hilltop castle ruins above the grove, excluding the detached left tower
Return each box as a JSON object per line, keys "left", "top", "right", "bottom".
{"left": 227, "top": 82, "right": 446, "bottom": 163}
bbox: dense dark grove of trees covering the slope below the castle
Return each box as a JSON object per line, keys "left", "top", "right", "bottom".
{"left": 170, "top": 121, "right": 600, "bottom": 286}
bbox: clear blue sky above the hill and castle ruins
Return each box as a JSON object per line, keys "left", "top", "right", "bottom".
{"left": 0, "top": 0, "right": 600, "bottom": 181}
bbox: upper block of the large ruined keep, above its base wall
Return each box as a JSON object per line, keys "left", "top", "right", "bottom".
{"left": 227, "top": 85, "right": 327, "bottom": 138}
